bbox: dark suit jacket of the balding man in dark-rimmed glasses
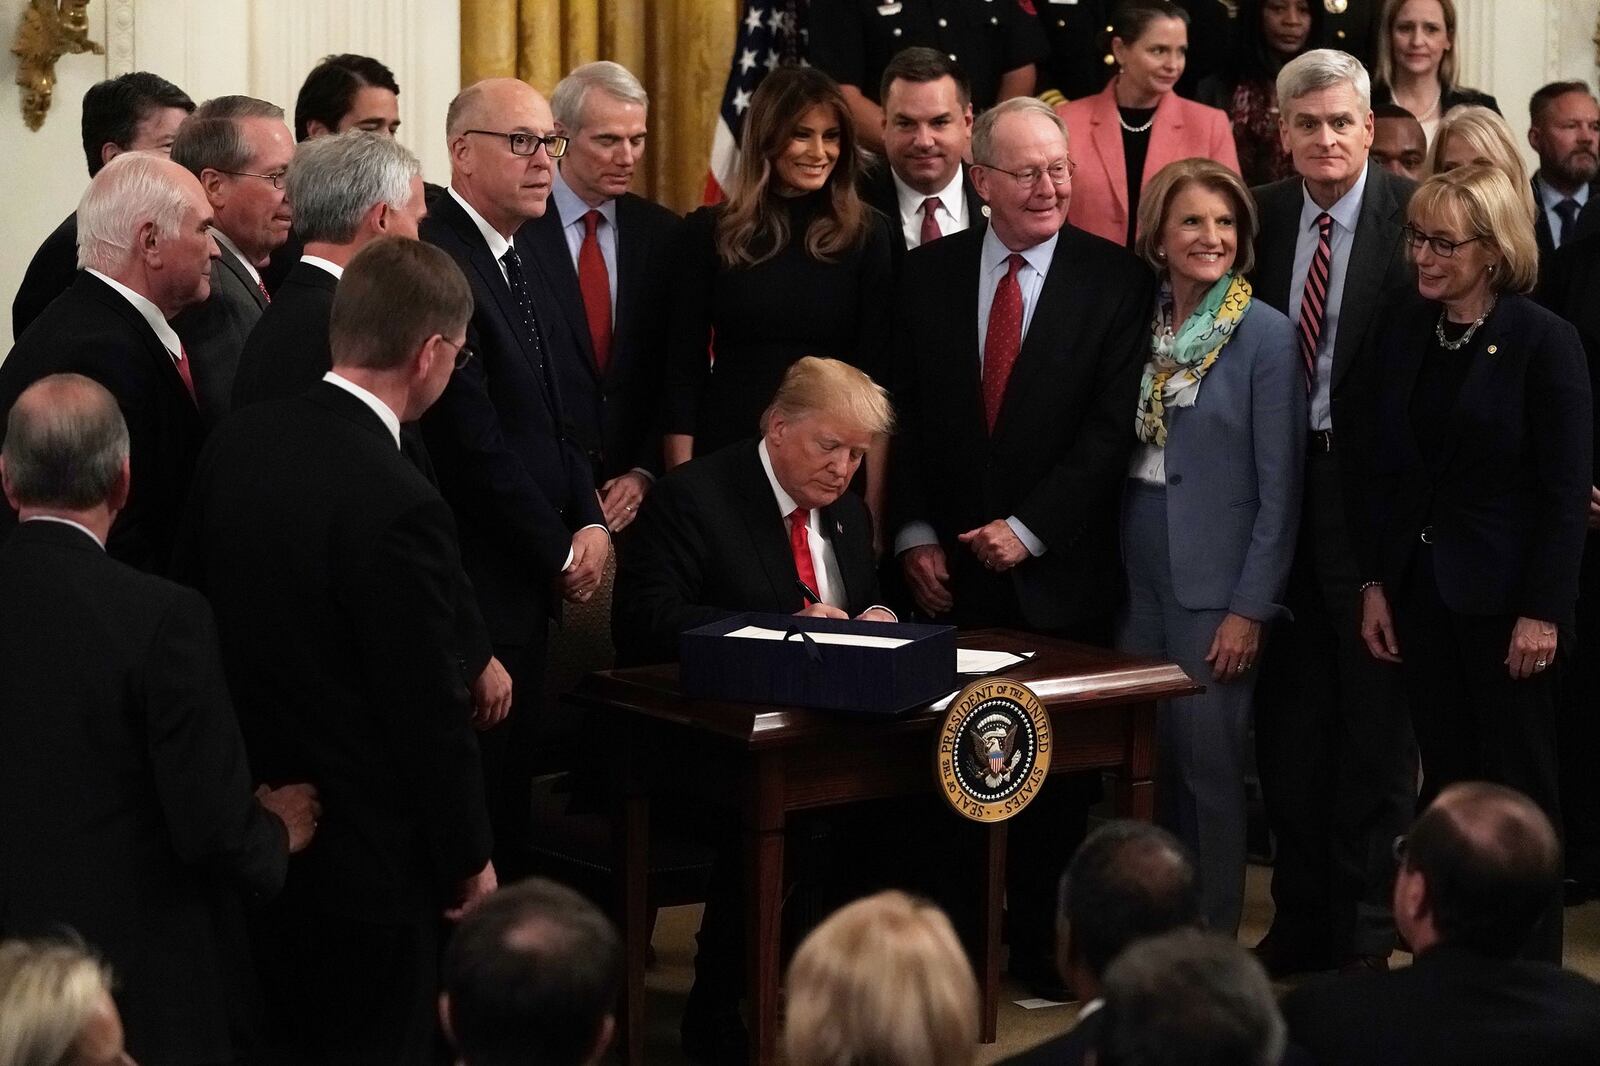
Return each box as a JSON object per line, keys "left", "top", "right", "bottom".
{"left": 421, "top": 192, "right": 605, "bottom": 643}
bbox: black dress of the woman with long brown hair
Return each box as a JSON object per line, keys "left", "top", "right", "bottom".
{"left": 664, "top": 189, "right": 893, "bottom": 455}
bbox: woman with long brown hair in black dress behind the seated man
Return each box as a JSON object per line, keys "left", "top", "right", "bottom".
{"left": 664, "top": 67, "right": 893, "bottom": 464}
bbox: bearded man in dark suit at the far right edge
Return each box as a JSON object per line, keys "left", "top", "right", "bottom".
{"left": 1528, "top": 82, "right": 1600, "bottom": 262}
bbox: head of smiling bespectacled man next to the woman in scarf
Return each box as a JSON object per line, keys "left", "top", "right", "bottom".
{"left": 971, "top": 96, "right": 1075, "bottom": 251}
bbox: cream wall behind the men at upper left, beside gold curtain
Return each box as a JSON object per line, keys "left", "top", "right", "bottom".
{"left": 0, "top": 0, "right": 461, "bottom": 352}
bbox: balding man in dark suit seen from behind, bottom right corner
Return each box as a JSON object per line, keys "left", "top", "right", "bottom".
{"left": 1283, "top": 781, "right": 1600, "bottom": 1066}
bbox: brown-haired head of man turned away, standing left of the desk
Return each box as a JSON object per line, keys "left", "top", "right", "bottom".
{"left": 328, "top": 237, "right": 472, "bottom": 423}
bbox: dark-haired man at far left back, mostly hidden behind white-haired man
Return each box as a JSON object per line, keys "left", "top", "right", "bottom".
{"left": 11, "top": 70, "right": 195, "bottom": 339}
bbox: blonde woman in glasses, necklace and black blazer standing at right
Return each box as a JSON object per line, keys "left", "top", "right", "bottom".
{"left": 1355, "top": 163, "right": 1592, "bottom": 952}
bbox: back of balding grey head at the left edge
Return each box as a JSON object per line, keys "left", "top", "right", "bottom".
{"left": 0, "top": 375, "right": 128, "bottom": 511}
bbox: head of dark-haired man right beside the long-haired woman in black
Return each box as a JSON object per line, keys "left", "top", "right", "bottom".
{"left": 878, "top": 46, "right": 973, "bottom": 197}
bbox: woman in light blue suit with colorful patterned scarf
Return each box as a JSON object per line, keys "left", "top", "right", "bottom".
{"left": 1118, "top": 158, "right": 1307, "bottom": 936}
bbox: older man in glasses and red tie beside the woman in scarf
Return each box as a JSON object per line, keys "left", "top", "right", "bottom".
{"left": 890, "top": 98, "right": 1152, "bottom": 986}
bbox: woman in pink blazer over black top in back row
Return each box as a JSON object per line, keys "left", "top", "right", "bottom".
{"left": 1056, "top": 0, "right": 1238, "bottom": 246}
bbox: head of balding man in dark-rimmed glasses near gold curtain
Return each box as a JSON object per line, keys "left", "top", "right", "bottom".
{"left": 445, "top": 78, "right": 566, "bottom": 238}
